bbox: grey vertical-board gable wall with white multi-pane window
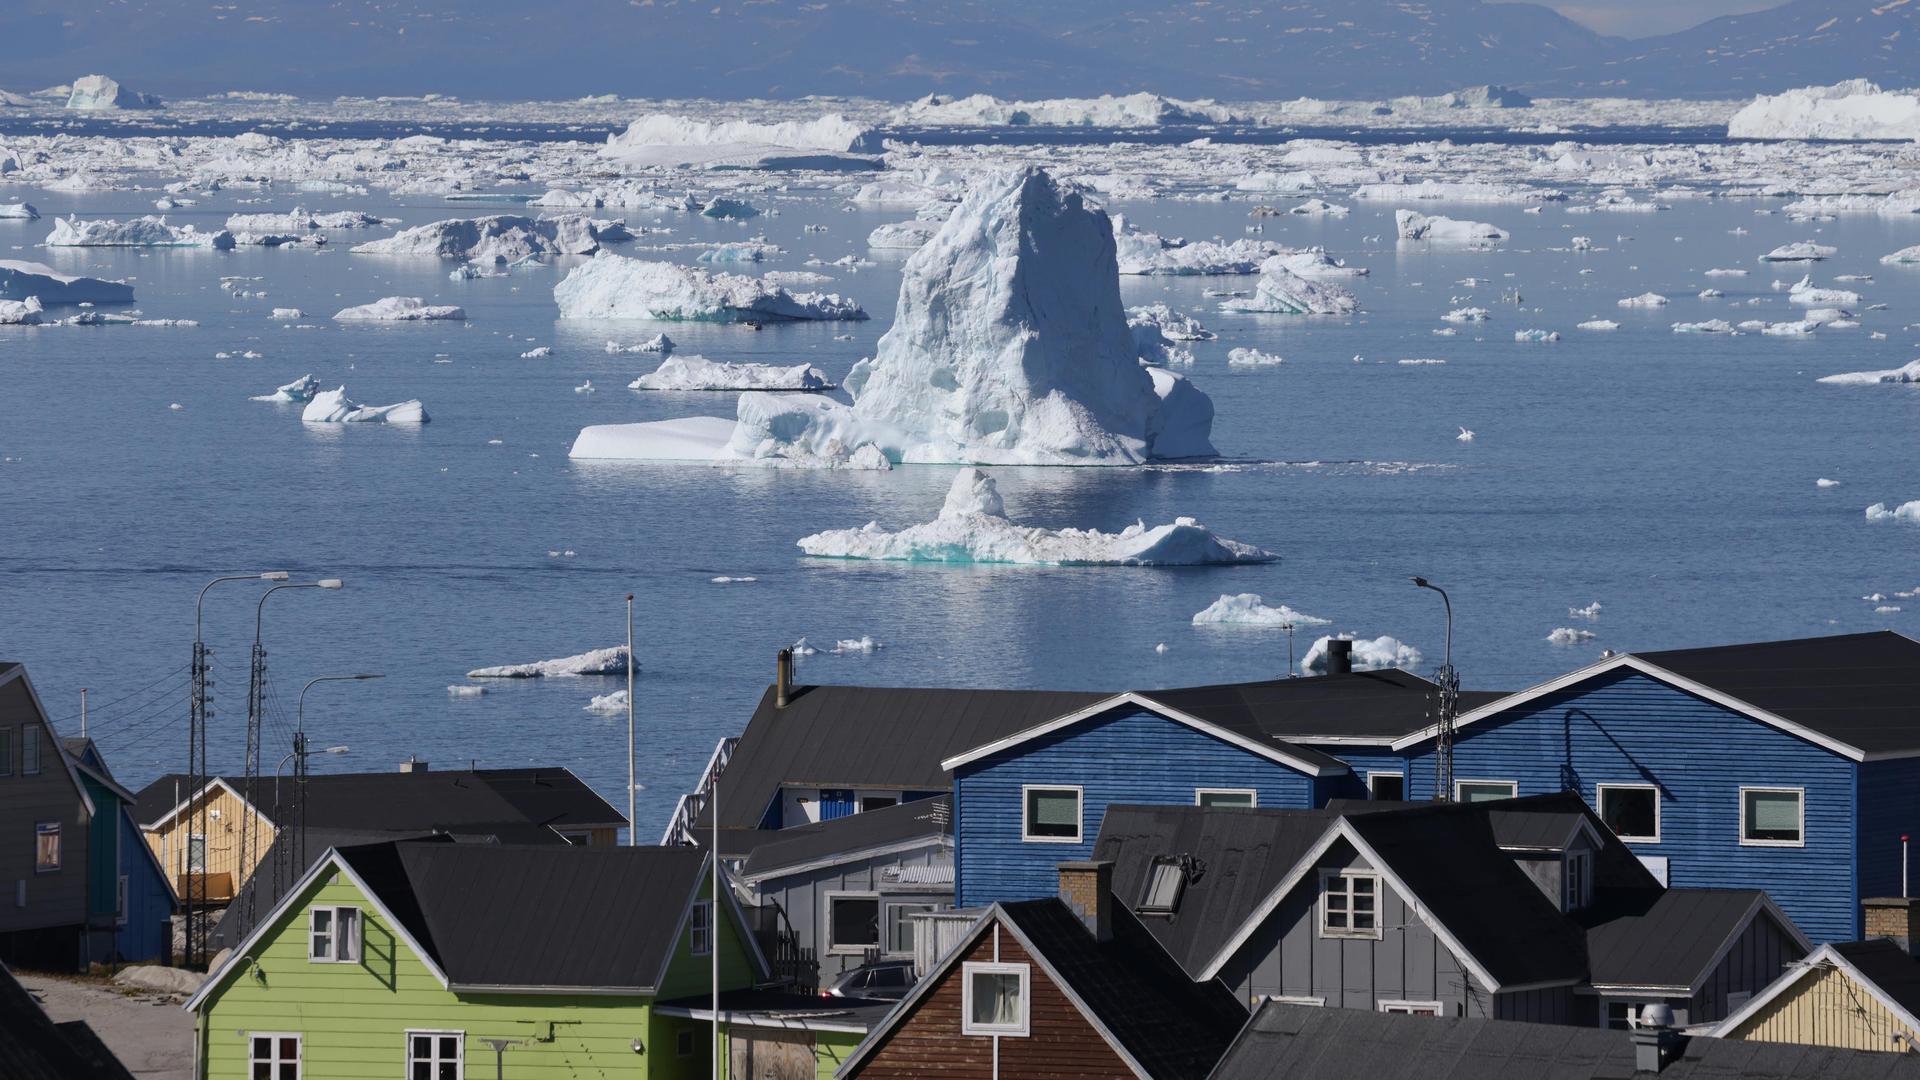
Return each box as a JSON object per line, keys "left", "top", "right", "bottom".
{"left": 1221, "top": 844, "right": 1494, "bottom": 1017}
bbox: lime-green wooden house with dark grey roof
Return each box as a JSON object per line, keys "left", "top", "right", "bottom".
{"left": 186, "top": 840, "right": 860, "bottom": 1080}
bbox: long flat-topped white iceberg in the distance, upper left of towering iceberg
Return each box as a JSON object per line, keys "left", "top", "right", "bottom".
{"left": 601, "top": 113, "right": 881, "bottom": 169}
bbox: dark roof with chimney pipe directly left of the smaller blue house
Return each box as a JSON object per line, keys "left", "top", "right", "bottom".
{"left": 699, "top": 686, "right": 1106, "bottom": 830}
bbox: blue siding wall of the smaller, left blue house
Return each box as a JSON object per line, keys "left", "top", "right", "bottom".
{"left": 954, "top": 709, "right": 1315, "bottom": 907}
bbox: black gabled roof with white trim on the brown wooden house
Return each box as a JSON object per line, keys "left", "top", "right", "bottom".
{"left": 837, "top": 899, "right": 1246, "bottom": 1080}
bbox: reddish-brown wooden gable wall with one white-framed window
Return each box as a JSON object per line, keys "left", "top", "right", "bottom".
{"left": 849, "top": 914, "right": 1133, "bottom": 1080}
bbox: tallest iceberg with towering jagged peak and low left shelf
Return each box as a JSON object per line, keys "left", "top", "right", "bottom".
{"left": 563, "top": 167, "right": 1215, "bottom": 467}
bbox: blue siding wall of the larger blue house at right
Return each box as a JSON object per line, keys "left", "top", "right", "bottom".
{"left": 1409, "top": 673, "right": 1860, "bottom": 942}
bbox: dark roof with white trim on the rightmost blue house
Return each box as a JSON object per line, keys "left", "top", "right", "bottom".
{"left": 1394, "top": 630, "right": 1920, "bottom": 761}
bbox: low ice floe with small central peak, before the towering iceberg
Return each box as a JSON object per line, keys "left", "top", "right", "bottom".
{"left": 799, "top": 469, "right": 1279, "bottom": 567}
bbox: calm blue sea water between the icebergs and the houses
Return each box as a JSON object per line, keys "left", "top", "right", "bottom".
{"left": 0, "top": 174, "right": 1920, "bottom": 838}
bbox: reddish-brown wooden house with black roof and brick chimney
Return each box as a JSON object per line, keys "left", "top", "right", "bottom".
{"left": 835, "top": 863, "right": 1246, "bottom": 1080}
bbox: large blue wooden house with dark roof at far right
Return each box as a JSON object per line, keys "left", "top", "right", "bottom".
{"left": 1390, "top": 632, "right": 1920, "bottom": 942}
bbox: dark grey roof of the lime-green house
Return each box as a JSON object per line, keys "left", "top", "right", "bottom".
{"left": 340, "top": 840, "right": 707, "bottom": 992}
